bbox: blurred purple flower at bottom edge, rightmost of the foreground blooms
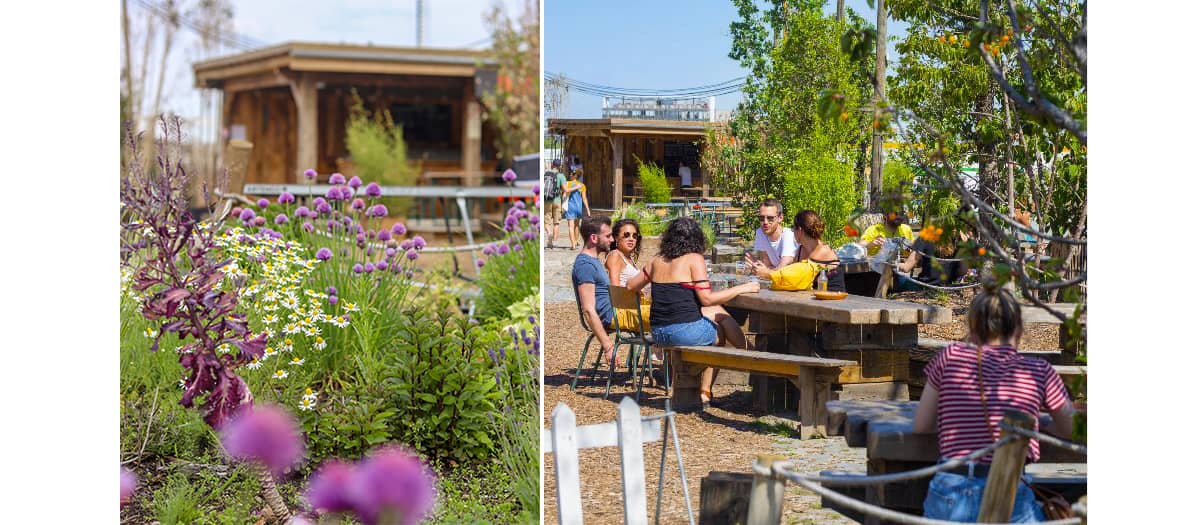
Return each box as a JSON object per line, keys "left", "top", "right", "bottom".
{"left": 348, "top": 446, "right": 434, "bottom": 524}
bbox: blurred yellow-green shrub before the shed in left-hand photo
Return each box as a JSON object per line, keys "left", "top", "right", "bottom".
{"left": 345, "top": 90, "right": 418, "bottom": 216}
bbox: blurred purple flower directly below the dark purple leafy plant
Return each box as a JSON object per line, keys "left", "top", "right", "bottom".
{"left": 221, "top": 405, "right": 303, "bottom": 477}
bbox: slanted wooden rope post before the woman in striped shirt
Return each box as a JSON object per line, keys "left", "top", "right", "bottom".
{"left": 979, "top": 411, "right": 1036, "bottom": 523}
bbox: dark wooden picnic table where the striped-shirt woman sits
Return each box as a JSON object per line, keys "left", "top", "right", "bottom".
{"left": 826, "top": 401, "right": 1086, "bottom": 512}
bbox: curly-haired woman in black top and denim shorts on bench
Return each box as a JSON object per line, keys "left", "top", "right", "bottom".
{"left": 627, "top": 217, "right": 760, "bottom": 405}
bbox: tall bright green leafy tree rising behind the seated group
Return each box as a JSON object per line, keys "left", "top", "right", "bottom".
{"left": 702, "top": 0, "right": 872, "bottom": 241}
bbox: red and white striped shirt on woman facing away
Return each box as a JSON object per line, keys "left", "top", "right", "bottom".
{"left": 926, "top": 342, "right": 1069, "bottom": 462}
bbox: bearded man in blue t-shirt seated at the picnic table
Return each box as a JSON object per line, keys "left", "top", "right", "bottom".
{"left": 572, "top": 216, "right": 620, "bottom": 367}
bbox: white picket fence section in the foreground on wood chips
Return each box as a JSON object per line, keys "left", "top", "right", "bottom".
{"left": 542, "top": 398, "right": 695, "bottom": 525}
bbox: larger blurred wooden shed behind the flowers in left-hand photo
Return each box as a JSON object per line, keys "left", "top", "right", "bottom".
{"left": 192, "top": 42, "right": 498, "bottom": 184}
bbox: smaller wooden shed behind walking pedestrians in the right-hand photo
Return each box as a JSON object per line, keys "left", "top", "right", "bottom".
{"left": 549, "top": 118, "right": 722, "bottom": 210}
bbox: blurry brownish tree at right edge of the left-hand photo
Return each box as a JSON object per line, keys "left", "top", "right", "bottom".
{"left": 483, "top": 0, "right": 540, "bottom": 163}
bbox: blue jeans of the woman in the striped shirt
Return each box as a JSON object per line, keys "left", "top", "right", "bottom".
{"left": 923, "top": 472, "right": 1044, "bottom": 523}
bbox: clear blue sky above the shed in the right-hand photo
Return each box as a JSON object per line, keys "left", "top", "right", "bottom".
{"left": 543, "top": 0, "right": 906, "bottom": 118}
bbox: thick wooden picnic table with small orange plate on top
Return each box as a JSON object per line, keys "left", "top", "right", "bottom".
{"left": 713, "top": 280, "right": 951, "bottom": 411}
